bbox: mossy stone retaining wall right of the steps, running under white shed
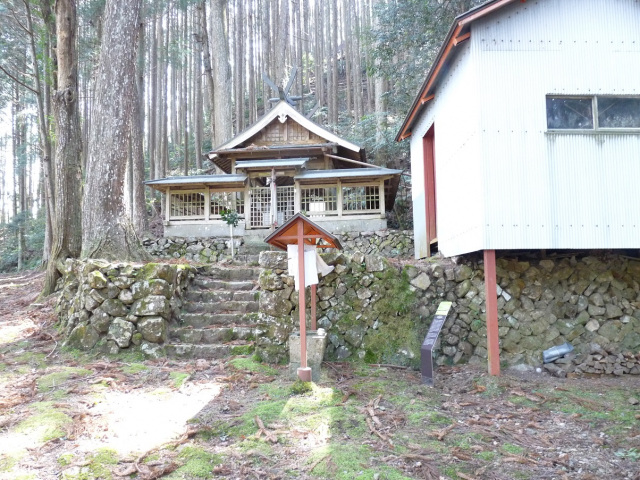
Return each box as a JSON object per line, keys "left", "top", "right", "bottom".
{"left": 258, "top": 252, "right": 640, "bottom": 365}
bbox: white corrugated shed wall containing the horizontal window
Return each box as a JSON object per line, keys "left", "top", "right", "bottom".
{"left": 476, "top": 0, "right": 640, "bottom": 253}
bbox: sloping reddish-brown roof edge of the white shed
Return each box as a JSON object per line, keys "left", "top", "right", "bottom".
{"left": 396, "top": 0, "right": 526, "bottom": 142}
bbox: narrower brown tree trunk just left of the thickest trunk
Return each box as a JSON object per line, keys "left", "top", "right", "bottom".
{"left": 42, "top": 0, "right": 82, "bottom": 295}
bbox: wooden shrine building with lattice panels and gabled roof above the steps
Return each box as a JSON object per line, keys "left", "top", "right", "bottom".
{"left": 146, "top": 101, "right": 401, "bottom": 237}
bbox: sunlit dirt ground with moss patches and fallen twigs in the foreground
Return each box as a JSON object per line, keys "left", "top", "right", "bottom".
{"left": 0, "top": 273, "right": 640, "bottom": 480}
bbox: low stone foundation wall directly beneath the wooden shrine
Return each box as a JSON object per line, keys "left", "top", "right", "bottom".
{"left": 142, "top": 230, "right": 414, "bottom": 263}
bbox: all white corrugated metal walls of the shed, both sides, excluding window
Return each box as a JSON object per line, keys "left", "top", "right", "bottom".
{"left": 411, "top": 0, "right": 640, "bottom": 256}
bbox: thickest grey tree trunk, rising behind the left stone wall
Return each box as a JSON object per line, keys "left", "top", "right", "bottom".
{"left": 82, "top": 0, "right": 148, "bottom": 261}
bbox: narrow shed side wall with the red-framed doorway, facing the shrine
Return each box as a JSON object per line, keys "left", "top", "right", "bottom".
{"left": 411, "top": 43, "right": 483, "bottom": 258}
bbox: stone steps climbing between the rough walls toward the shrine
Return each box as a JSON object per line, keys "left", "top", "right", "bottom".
{"left": 166, "top": 264, "right": 260, "bottom": 358}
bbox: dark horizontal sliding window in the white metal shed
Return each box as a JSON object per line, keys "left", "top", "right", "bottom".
{"left": 547, "top": 96, "right": 640, "bottom": 130}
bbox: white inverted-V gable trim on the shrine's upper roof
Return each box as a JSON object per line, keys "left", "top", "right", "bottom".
{"left": 208, "top": 100, "right": 362, "bottom": 159}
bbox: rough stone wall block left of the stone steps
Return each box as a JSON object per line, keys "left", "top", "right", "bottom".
{"left": 56, "top": 260, "right": 195, "bottom": 356}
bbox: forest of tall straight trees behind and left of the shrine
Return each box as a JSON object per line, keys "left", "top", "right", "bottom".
{"left": 0, "top": 0, "right": 482, "bottom": 272}
